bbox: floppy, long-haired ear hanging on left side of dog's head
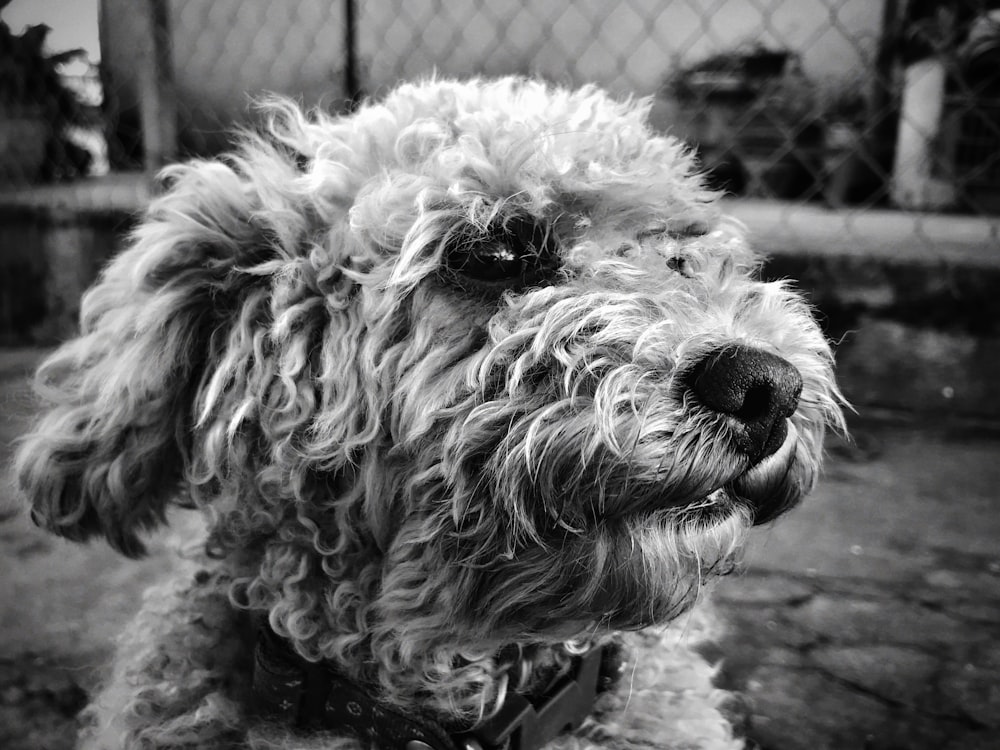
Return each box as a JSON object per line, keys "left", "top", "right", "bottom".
{"left": 16, "top": 162, "right": 274, "bottom": 556}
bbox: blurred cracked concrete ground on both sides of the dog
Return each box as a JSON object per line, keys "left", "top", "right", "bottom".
{"left": 0, "top": 349, "right": 1000, "bottom": 750}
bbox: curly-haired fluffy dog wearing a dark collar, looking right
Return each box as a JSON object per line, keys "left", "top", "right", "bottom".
{"left": 17, "top": 78, "right": 842, "bottom": 750}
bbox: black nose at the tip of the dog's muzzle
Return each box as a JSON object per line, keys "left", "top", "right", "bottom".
{"left": 685, "top": 344, "right": 802, "bottom": 461}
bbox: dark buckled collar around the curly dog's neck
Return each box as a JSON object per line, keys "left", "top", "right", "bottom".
{"left": 253, "top": 625, "right": 622, "bottom": 750}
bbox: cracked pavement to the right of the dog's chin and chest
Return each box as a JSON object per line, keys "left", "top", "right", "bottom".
{"left": 716, "top": 421, "right": 1000, "bottom": 750}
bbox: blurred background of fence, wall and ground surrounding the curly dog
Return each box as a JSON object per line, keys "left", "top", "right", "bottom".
{"left": 0, "top": 0, "right": 1000, "bottom": 750}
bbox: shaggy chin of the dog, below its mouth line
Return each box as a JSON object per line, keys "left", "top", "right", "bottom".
{"left": 461, "top": 490, "right": 752, "bottom": 641}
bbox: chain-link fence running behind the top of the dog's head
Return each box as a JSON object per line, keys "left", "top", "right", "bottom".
{"left": 0, "top": 0, "right": 1000, "bottom": 242}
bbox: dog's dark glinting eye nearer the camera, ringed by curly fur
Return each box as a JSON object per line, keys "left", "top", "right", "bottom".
{"left": 445, "top": 219, "right": 559, "bottom": 288}
